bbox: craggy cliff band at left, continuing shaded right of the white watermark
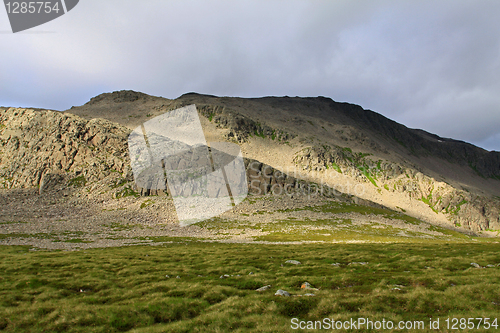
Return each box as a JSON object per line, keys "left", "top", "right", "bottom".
{"left": 0, "top": 108, "right": 386, "bottom": 213}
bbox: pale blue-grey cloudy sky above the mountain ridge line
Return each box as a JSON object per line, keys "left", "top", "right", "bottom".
{"left": 0, "top": 0, "right": 500, "bottom": 151}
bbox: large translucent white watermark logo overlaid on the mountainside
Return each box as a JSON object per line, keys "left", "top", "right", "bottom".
{"left": 128, "top": 105, "right": 248, "bottom": 226}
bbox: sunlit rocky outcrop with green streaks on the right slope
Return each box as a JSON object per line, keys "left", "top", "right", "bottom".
{"left": 294, "top": 146, "right": 500, "bottom": 231}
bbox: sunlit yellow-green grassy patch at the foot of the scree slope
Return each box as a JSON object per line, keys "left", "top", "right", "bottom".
{"left": 192, "top": 202, "right": 480, "bottom": 243}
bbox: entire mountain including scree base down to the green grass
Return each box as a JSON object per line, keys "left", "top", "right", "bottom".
{"left": 0, "top": 91, "right": 500, "bottom": 248}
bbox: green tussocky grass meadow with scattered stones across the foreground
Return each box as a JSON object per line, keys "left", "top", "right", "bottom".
{"left": 0, "top": 242, "right": 500, "bottom": 332}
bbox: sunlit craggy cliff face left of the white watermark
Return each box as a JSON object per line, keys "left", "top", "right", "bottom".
{"left": 0, "top": 108, "right": 130, "bottom": 190}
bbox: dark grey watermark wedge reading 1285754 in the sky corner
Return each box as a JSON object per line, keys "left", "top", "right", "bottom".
{"left": 4, "top": 0, "right": 79, "bottom": 33}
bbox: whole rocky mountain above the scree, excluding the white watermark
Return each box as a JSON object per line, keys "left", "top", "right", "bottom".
{"left": 0, "top": 91, "right": 500, "bottom": 235}
